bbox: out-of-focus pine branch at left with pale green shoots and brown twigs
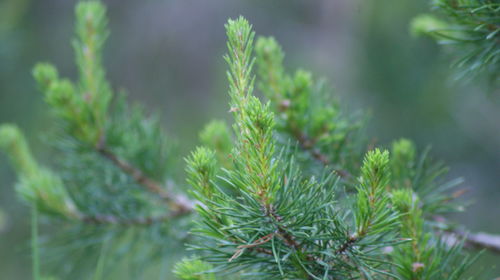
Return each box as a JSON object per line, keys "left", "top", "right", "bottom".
{"left": 12, "top": 1, "right": 194, "bottom": 232}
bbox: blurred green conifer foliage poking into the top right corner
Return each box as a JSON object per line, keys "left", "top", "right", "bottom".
{"left": 412, "top": 0, "right": 500, "bottom": 83}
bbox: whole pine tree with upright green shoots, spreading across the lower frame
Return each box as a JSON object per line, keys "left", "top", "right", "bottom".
{"left": 0, "top": 1, "right": 500, "bottom": 280}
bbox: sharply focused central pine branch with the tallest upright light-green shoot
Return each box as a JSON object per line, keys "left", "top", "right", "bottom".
{"left": 187, "top": 18, "right": 344, "bottom": 279}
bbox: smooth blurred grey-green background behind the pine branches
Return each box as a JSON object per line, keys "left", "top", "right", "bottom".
{"left": 0, "top": 0, "right": 500, "bottom": 279}
